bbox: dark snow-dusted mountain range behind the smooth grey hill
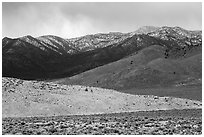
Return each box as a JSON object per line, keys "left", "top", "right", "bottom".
{"left": 2, "top": 27, "right": 202, "bottom": 79}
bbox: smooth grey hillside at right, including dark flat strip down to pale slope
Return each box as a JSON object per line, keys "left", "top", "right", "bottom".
{"left": 55, "top": 45, "right": 202, "bottom": 100}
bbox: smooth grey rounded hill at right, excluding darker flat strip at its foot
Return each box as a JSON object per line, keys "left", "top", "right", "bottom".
{"left": 57, "top": 45, "right": 202, "bottom": 89}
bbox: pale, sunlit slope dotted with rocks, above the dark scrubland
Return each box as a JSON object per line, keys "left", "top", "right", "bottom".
{"left": 2, "top": 78, "right": 202, "bottom": 117}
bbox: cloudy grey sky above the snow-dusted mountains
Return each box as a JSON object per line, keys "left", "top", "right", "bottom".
{"left": 2, "top": 2, "right": 202, "bottom": 38}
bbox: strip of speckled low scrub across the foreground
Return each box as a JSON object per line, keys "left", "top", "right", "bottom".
{"left": 2, "top": 109, "right": 202, "bottom": 135}
